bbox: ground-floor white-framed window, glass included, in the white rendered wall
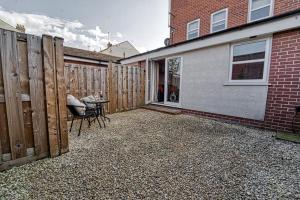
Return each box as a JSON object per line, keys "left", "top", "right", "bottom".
{"left": 230, "top": 39, "right": 269, "bottom": 82}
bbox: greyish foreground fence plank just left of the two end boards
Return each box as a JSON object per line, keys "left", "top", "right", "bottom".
{"left": 27, "top": 35, "right": 49, "bottom": 156}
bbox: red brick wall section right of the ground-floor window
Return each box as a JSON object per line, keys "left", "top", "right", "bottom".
{"left": 265, "top": 29, "right": 300, "bottom": 131}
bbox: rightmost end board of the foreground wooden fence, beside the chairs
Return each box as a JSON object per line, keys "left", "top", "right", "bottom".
{"left": 55, "top": 38, "right": 68, "bottom": 153}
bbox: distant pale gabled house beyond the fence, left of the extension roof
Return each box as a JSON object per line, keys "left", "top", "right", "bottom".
{"left": 100, "top": 41, "right": 140, "bottom": 58}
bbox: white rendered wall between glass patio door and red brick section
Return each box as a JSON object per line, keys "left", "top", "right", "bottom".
{"left": 180, "top": 44, "right": 268, "bottom": 121}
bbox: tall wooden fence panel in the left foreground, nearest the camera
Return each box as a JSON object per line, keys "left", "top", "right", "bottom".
{"left": 0, "top": 29, "right": 68, "bottom": 171}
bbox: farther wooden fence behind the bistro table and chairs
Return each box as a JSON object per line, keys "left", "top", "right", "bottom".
{"left": 65, "top": 63, "right": 145, "bottom": 113}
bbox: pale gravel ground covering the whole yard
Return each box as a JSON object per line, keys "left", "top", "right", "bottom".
{"left": 0, "top": 109, "right": 300, "bottom": 199}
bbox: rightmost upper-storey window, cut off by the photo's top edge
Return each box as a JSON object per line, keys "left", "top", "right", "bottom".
{"left": 249, "top": 0, "right": 273, "bottom": 22}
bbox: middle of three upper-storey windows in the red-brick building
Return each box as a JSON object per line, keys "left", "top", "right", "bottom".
{"left": 210, "top": 8, "right": 228, "bottom": 33}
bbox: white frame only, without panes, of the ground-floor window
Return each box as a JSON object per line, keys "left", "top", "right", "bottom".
{"left": 228, "top": 37, "right": 272, "bottom": 85}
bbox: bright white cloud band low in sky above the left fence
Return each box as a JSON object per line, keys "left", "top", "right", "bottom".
{"left": 0, "top": 7, "right": 123, "bottom": 51}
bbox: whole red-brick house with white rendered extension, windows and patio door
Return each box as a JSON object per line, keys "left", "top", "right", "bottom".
{"left": 120, "top": 0, "right": 300, "bottom": 131}
